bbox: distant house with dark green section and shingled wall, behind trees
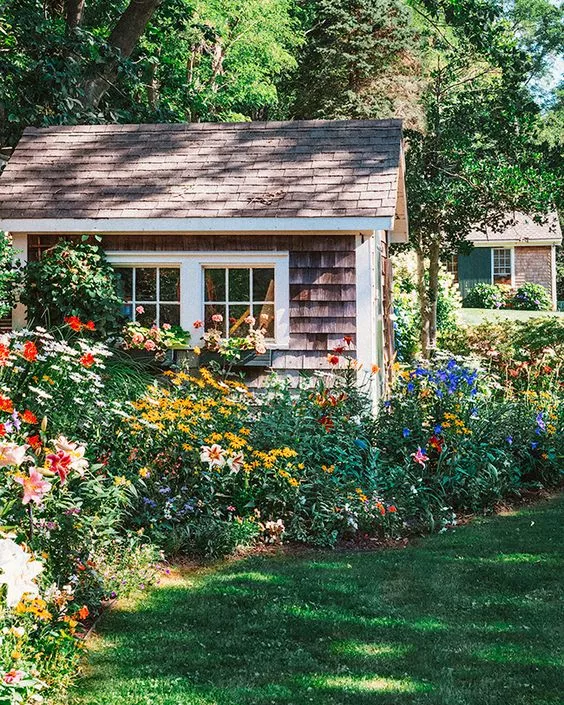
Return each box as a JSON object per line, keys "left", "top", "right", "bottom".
{"left": 448, "top": 213, "right": 562, "bottom": 308}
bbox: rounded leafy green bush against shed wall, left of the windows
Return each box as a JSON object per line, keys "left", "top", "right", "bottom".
{"left": 21, "top": 240, "right": 123, "bottom": 334}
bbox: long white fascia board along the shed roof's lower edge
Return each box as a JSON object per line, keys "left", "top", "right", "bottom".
{"left": 0, "top": 216, "right": 393, "bottom": 233}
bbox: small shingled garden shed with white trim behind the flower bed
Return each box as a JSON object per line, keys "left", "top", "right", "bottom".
{"left": 0, "top": 120, "right": 407, "bottom": 398}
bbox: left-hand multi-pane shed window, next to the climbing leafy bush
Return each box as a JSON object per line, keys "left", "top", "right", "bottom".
{"left": 115, "top": 265, "right": 180, "bottom": 327}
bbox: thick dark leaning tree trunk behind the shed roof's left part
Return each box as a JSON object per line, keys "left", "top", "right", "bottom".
{"left": 84, "top": 0, "right": 162, "bottom": 109}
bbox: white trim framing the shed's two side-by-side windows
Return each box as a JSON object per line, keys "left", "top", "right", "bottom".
{"left": 106, "top": 251, "right": 290, "bottom": 350}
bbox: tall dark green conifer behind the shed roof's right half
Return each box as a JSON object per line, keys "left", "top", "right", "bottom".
{"left": 289, "top": 0, "right": 417, "bottom": 118}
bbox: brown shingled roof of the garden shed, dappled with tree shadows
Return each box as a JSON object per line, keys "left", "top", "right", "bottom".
{"left": 0, "top": 120, "right": 403, "bottom": 219}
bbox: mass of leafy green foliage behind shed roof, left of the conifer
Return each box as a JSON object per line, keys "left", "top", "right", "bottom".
{"left": 0, "top": 0, "right": 302, "bottom": 144}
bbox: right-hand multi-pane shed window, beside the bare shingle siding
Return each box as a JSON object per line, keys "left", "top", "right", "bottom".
{"left": 204, "top": 267, "right": 275, "bottom": 339}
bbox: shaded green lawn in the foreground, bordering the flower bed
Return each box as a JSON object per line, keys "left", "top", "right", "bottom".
{"left": 71, "top": 497, "right": 564, "bottom": 705}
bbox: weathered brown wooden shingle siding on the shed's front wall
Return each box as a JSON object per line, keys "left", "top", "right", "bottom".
{"left": 29, "top": 233, "right": 356, "bottom": 380}
